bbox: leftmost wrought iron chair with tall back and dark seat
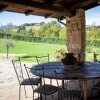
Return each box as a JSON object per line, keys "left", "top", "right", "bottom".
{"left": 12, "top": 58, "right": 40, "bottom": 100}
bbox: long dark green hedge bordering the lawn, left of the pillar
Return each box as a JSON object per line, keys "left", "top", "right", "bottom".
{"left": 0, "top": 33, "right": 66, "bottom": 44}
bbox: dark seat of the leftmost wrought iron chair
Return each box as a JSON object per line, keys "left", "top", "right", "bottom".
{"left": 21, "top": 78, "right": 41, "bottom": 85}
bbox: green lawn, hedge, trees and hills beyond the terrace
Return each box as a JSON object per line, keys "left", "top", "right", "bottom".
{"left": 0, "top": 21, "right": 100, "bottom": 61}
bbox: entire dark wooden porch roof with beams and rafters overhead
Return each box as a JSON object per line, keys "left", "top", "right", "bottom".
{"left": 0, "top": 0, "right": 99, "bottom": 18}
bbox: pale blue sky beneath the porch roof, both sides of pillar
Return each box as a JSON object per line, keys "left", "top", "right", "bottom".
{"left": 0, "top": 6, "right": 100, "bottom": 26}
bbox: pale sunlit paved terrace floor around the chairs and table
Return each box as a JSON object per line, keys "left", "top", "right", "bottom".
{"left": 0, "top": 57, "right": 100, "bottom": 100}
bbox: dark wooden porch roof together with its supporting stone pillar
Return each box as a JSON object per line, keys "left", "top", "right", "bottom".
{"left": 0, "top": 0, "right": 99, "bottom": 100}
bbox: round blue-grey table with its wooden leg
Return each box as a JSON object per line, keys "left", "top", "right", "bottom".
{"left": 31, "top": 62, "right": 100, "bottom": 100}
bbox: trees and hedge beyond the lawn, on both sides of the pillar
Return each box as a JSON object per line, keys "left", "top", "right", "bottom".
{"left": 0, "top": 21, "right": 100, "bottom": 53}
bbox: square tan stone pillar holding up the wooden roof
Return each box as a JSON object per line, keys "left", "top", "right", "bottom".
{"left": 67, "top": 9, "right": 86, "bottom": 61}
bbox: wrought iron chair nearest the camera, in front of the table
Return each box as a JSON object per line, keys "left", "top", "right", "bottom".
{"left": 24, "top": 65, "right": 61, "bottom": 100}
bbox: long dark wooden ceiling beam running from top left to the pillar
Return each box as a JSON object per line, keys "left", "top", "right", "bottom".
{"left": 0, "top": 0, "right": 74, "bottom": 16}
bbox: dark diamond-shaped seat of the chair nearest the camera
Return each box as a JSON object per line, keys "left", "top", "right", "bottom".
{"left": 35, "top": 84, "right": 59, "bottom": 95}
